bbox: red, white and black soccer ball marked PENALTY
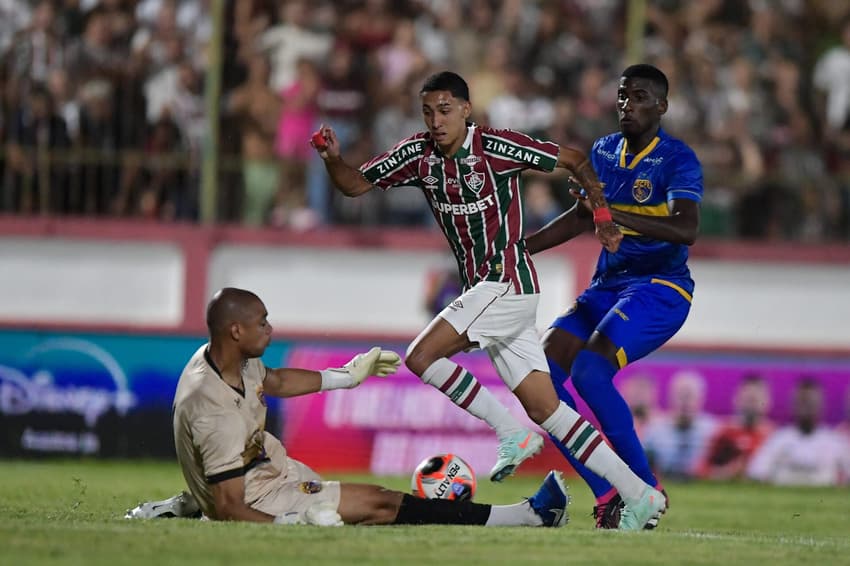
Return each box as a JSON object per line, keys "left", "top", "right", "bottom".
{"left": 410, "top": 454, "right": 475, "bottom": 501}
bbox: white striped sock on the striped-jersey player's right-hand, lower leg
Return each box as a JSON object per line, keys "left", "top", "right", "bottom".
{"left": 540, "top": 401, "right": 646, "bottom": 503}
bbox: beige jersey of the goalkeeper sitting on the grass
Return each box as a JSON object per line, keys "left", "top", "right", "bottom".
{"left": 174, "top": 344, "right": 287, "bottom": 517}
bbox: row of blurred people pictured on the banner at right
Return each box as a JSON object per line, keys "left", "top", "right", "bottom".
{"left": 624, "top": 369, "right": 850, "bottom": 486}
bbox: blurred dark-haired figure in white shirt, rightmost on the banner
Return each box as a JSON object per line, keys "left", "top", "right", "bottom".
{"left": 747, "top": 378, "right": 850, "bottom": 485}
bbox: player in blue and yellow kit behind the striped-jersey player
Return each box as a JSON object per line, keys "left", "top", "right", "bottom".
{"left": 526, "top": 64, "right": 703, "bottom": 528}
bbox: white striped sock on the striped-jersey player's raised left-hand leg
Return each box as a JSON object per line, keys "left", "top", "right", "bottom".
{"left": 421, "top": 358, "right": 523, "bottom": 438}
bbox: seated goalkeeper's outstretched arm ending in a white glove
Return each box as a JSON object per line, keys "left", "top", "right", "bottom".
{"left": 263, "top": 346, "right": 401, "bottom": 397}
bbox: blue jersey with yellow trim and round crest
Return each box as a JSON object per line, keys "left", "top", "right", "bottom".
{"left": 590, "top": 129, "right": 702, "bottom": 293}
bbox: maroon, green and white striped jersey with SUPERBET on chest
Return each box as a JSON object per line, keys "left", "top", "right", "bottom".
{"left": 360, "top": 124, "right": 559, "bottom": 293}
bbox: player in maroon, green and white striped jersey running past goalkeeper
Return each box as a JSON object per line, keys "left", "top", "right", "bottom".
{"left": 312, "top": 72, "right": 661, "bottom": 528}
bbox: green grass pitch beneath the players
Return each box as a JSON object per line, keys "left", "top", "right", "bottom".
{"left": 0, "top": 460, "right": 850, "bottom": 566}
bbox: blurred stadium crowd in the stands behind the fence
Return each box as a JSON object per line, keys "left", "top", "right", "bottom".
{"left": 0, "top": 0, "right": 850, "bottom": 242}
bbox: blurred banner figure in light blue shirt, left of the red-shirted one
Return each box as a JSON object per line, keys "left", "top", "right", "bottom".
{"left": 642, "top": 371, "right": 716, "bottom": 478}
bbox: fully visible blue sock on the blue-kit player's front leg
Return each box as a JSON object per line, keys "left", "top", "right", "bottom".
{"left": 572, "top": 350, "right": 658, "bottom": 486}
